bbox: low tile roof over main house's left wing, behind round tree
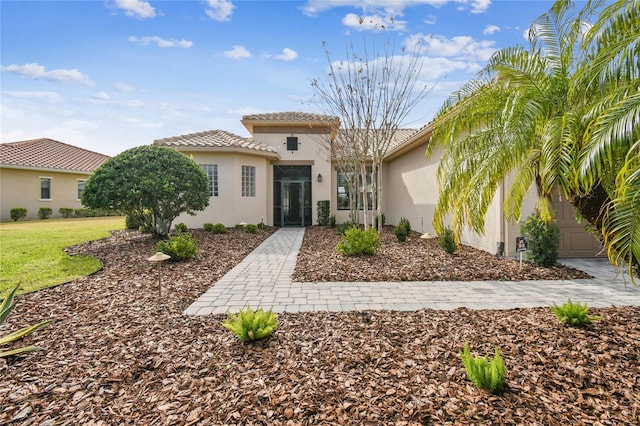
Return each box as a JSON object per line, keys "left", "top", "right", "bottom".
{"left": 153, "top": 130, "right": 278, "bottom": 153}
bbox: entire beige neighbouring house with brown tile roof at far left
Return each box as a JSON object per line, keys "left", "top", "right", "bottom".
{"left": 0, "top": 138, "right": 109, "bottom": 221}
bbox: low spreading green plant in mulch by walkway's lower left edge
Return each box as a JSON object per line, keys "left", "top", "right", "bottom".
{"left": 222, "top": 306, "right": 278, "bottom": 342}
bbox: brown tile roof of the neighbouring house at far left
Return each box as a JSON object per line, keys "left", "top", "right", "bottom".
{"left": 0, "top": 138, "right": 109, "bottom": 172}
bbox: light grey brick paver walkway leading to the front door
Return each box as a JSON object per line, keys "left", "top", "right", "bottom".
{"left": 184, "top": 228, "right": 640, "bottom": 315}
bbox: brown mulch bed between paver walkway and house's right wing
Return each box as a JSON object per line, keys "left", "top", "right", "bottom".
{"left": 293, "top": 226, "right": 591, "bottom": 282}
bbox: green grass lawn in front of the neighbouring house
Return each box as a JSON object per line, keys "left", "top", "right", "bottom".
{"left": 0, "top": 216, "right": 124, "bottom": 297}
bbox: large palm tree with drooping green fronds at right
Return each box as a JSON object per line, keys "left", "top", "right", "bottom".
{"left": 427, "top": 0, "right": 640, "bottom": 276}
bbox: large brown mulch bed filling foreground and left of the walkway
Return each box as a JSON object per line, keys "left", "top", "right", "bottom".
{"left": 0, "top": 226, "right": 640, "bottom": 425}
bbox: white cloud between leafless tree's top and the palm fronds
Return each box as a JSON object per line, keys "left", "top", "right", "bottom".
{"left": 405, "top": 34, "right": 496, "bottom": 61}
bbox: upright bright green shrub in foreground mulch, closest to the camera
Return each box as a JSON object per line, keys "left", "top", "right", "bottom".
{"left": 460, "top": 343, "right": 506, "bottom": 394}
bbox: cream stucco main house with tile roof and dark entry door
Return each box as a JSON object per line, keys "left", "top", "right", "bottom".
{"left": 154, "top": 112, "right": 599, "bottom": 257}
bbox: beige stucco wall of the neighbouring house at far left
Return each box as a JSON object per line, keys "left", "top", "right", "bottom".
{"left": 0, "top": 167, "right": 89, "bottom": 221}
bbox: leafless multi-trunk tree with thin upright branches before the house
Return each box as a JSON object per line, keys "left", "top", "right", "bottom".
{"left": 311, "top": 40, "right": 430, "bottom": 229}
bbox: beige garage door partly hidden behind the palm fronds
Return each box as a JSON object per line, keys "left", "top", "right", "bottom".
{"left": 553, "top": 198, "right": 605, "bottom": 258}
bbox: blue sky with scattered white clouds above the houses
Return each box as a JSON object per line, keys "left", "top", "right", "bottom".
{"left": 0, "top": 0, "right": 564, "bottom": 155}
